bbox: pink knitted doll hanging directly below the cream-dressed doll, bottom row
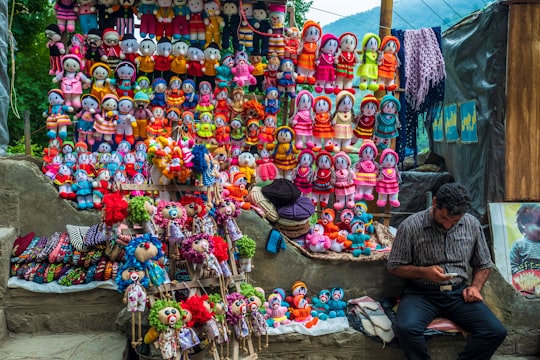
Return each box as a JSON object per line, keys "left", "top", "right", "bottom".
{"left": 334, "top": 151, "right": 355, "bottom": 211}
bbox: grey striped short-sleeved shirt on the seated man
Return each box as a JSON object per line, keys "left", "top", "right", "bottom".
{"left": 387, "top": 209, "right": 493, "bottom": 286}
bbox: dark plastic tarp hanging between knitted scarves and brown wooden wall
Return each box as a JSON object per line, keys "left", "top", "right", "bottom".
{"left": 430, "top": 2, "right": 508, "bottom": 219}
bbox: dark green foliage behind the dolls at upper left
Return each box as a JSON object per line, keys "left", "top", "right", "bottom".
{"left": 7, "top": 0, "right": 55, "bottom": 152}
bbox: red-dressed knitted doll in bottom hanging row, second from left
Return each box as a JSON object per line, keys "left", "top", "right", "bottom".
{"left": 311, "top": 151, "right": 335, "bottom": 209}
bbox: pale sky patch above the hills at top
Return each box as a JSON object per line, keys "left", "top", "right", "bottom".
{"left": 306, "top": 0, "right": 381, "bottom": 26}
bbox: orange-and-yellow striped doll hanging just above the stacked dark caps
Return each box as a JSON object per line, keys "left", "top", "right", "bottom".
{"left": 272, "top": 126, "right": 298, "bottom": 180}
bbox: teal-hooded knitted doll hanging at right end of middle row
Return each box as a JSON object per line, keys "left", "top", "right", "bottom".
{"left": 373, "top": 95, "right": 401, "bottom": 149}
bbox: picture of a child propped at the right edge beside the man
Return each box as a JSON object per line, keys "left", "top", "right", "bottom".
{"left": 488, "top": 203, "right": 540, "bottom": 297}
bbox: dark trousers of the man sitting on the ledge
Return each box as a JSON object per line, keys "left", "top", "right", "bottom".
{"left": 395, "top": 287, "right": 507, "bottom": 360}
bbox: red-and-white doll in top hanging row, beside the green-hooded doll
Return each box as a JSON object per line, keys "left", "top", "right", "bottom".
{"left": 334, "top": 32, "right": 358, "bottom": 95}
